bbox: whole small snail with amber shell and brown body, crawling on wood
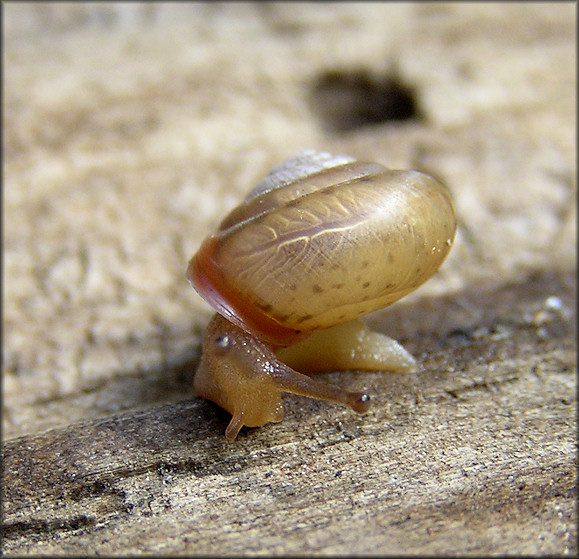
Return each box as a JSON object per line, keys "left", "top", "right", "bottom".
{"left": 186, "top": 150, "right": 456, "bottom": 440}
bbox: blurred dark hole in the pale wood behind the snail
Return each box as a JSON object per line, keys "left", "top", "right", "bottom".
{"left": 311, "top": 70, "right": 421, "bottom": 132}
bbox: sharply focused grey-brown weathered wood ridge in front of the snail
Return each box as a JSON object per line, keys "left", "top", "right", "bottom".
{"left": 2, "top": 273, "right": 577, "bottom": 555}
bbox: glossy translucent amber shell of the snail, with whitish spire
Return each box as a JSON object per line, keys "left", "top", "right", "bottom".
{"left": 187, "top": 151, "right": 456, "bottom": 346}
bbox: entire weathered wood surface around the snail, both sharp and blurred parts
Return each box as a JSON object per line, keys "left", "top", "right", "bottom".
{"left": 2, "top": 3, "right": 577, "bottom": 556}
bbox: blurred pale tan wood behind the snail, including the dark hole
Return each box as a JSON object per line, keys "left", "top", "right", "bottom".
{"left": 3, "top": 2, "right": 576, "bottom": 438}
